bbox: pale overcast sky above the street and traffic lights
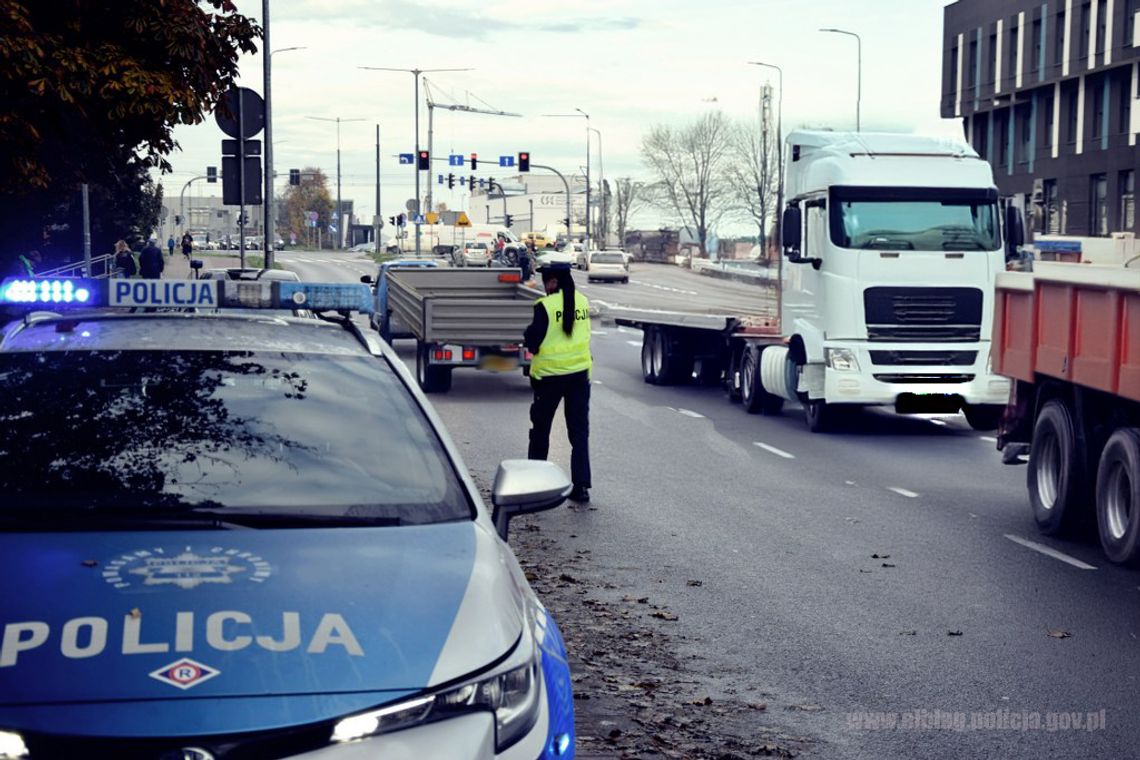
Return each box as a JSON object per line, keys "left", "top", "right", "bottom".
{"left": 162, "top": 0, "right": 961, "bottom": 229}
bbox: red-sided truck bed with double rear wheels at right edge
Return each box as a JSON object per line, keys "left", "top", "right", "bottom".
{"left": 993, "top": 262, "right": 1140, "bottom": 564}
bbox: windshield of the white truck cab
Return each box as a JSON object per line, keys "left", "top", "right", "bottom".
{"left": 830, "top": 187, "right": 1001, "bottom": 251}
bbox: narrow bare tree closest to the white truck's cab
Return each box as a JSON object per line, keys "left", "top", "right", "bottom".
{"left": 725, "top": 117, "right": 780, "bottom": 256}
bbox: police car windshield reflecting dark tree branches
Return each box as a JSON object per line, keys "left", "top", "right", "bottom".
{"left": 0, "top": 351, "right": 473, "bottom": 523}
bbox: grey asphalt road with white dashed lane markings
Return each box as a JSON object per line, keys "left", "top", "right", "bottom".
{"left": 271, "top": 250, "right": 1140, "bottom": 758}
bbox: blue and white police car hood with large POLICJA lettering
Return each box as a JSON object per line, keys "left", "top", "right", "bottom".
{"left": 0, "top": 522, "right": 526, "bottom": 735}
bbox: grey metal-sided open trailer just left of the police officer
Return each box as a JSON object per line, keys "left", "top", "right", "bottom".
{"left": 383, "top": 268, "right": 543, "bottom": 393}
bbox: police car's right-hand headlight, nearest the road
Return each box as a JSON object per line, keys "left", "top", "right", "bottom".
{"left": 330, "top": 634, "right": 542, "bottom": 760}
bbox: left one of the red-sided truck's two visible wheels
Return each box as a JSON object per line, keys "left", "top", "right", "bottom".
{"left": 1026, "top": 399, "right": 1085, "bottom": 536}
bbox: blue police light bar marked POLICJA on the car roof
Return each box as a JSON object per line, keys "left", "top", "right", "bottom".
{"left": 0, "top": 278, "right": 372, "bottom": 312}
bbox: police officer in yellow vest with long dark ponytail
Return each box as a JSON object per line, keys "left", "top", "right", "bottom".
{"left": 523, "top": 263, "right": 593, "bottom": 504}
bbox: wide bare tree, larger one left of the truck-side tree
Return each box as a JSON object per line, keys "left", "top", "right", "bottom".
{"left": 642, "top": 111, "right": 732, "bottom": 258}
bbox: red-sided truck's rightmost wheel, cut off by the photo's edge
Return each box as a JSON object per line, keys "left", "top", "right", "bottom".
{"left": 1097, "top": 427, "right": 1140, "bottom": 565}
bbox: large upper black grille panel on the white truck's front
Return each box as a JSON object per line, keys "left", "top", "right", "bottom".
{"left": 863, "top": 287, "right": 982, "bottom": 342}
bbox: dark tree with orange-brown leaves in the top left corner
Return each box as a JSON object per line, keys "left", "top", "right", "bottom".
{"left": 0, "top": 0, "right": 261, "bottom": 264}
